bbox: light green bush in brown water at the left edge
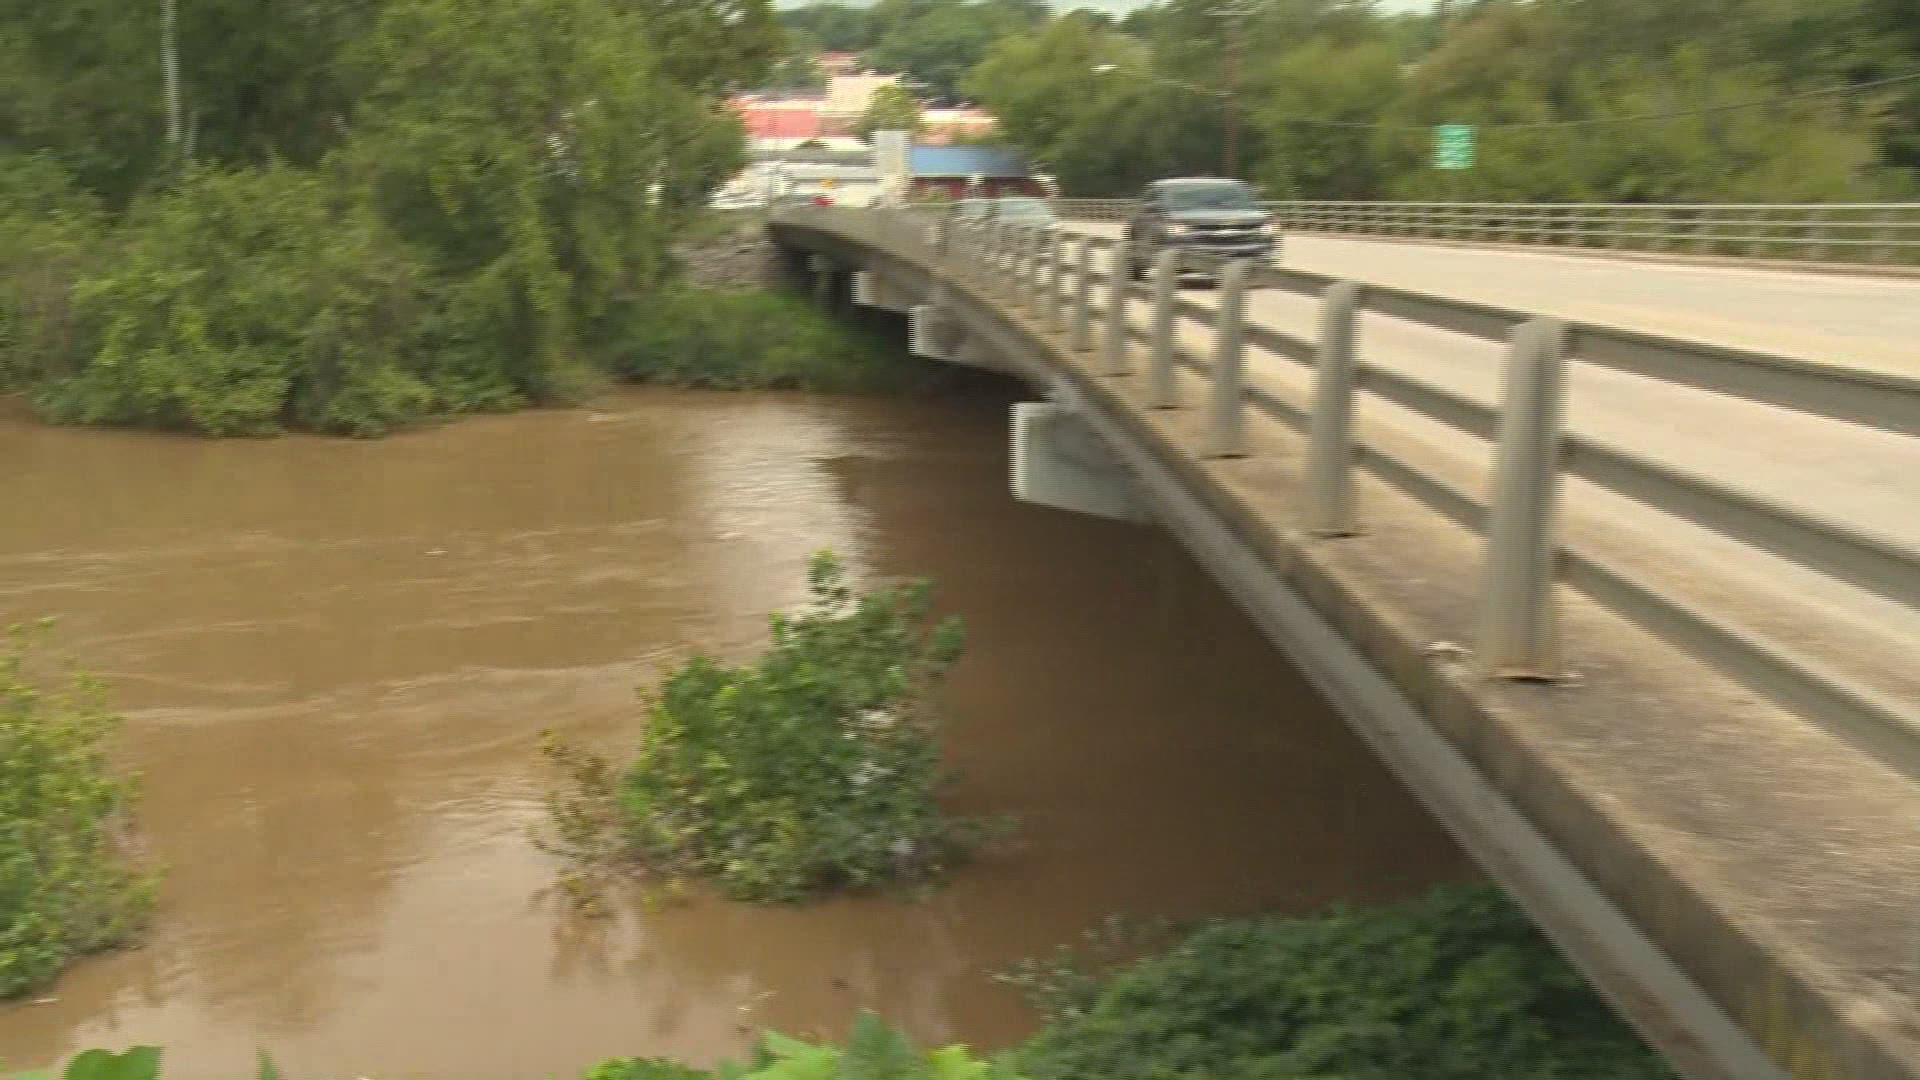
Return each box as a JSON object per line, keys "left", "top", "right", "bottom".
{"left": 0, "top": 628, "right": 154, "bottom": 997}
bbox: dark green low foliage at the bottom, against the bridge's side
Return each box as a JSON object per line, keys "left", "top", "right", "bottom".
{"left": 1012, "top": 886, "right": 1672, "bottom": 1080}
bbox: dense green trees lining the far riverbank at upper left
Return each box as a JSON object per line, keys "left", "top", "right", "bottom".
{"left": 0, "top": 0, "right": 856, "bottom": 434}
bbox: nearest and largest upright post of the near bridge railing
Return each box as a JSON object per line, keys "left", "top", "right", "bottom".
{"left": 1476, "top": 319, "right": 1567, "bottom": 678}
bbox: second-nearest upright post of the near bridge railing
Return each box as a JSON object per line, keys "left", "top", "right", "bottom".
{"left": 1308, "top": 281, "right": 1359, "bottom": 536}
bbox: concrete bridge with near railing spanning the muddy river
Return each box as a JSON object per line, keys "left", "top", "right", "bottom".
{"left": 772, "top": 208, "right": 1920, "bottom": 1080}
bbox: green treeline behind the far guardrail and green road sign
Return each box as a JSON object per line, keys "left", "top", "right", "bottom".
{"left": 783, "top": 0, "right": 1920, "bottom": 202}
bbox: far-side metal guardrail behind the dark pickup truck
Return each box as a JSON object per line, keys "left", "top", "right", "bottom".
{"left": 1054, "top": 198, "right": 1920, "bottom": 267}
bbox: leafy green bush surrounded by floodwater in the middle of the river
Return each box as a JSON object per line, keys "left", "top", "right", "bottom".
{"left": 547, "top": 555, "right": 983, "bottom": 901}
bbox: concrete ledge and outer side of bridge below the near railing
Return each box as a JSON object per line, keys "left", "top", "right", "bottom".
{"left": 776, "top": 223, "right": 1920, "bottom": 1080}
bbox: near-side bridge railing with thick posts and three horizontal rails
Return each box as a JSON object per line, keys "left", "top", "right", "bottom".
{"left": 783, "top": 208, "right": 1920, "bottom": 757}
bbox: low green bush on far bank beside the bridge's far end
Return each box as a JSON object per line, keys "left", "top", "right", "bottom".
{"left": 609, "top": 286, "right": 918, "bottom": 390}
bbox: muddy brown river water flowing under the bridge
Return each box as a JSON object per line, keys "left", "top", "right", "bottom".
{"left": 0, "top": 384, "right": 1469, "bottom": 1080}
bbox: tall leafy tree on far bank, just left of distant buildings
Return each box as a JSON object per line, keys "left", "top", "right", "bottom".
{"left": 344, "top": 0, "right": 741, "bottom": 400}
